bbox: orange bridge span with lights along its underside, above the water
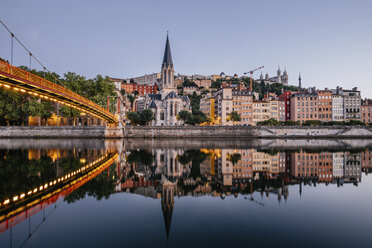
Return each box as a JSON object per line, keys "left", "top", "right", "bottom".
{"left": 0, "top": 61, "right": 118, "bottom": 124}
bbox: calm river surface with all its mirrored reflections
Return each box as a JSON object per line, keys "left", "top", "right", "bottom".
{"left": 0, "top": 140, "right": 372, "bottom": 247}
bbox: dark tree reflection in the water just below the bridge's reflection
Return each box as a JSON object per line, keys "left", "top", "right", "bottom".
{"left": 64, "top": 163, "right": 116, "bottom": 203}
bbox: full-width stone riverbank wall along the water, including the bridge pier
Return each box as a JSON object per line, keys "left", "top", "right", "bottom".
{"left": 0, "top": 126, "right": 372, "bottom": 139}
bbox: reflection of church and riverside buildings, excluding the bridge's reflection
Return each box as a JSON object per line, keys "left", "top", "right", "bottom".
{"left": 118, "top": 149, "right": 372, "bottom": 236}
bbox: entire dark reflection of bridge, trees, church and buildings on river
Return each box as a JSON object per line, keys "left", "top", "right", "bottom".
{"left": 0, "top": 140, "right": 372, "bottom": 247}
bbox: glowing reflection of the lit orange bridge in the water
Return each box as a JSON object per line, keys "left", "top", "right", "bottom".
{"left": 0, "top": 153, "right": 119, "bottom": 233}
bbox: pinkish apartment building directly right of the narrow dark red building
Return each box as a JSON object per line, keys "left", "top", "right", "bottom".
{"left": 290, "top": 92, "right": 318, "bottom": 123}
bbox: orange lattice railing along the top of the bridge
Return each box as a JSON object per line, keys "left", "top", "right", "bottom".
{"left": 0, "top": 61, "right": 116, "bottom": 122}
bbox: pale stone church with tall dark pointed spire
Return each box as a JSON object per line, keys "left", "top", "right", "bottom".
{"left": 142, "top": 35, "right": 191, "bottom": 126}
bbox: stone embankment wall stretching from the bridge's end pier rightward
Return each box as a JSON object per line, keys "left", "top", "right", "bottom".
{"left": 123, "top": 126, "right": 372, "bottom": 138}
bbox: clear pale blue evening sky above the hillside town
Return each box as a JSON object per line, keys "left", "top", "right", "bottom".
{"left": 0, "top": 0, "right": 372, "bottom": 98}
